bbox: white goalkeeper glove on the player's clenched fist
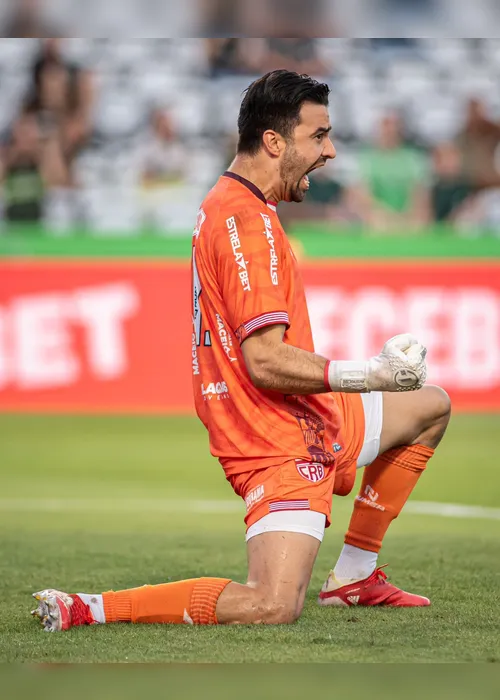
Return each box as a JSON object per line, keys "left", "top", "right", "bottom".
{"left": 325, "top": 333, "right": 427, "bottom": 393}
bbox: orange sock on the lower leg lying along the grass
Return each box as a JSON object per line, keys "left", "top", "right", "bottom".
{"left": 102, "top": 578, "right": 231, "bottom": 625}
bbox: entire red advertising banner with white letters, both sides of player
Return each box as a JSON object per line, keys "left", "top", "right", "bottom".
{"left": 0, "top": 260, "right": 500, "bottom": 413}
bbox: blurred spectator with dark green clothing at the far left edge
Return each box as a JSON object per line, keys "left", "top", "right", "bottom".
{"left": 0, "top": 112, "right": 67, "bottom": 223}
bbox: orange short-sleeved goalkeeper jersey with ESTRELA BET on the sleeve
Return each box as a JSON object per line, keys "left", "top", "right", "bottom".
{"left": 192, "top": 173, "right": 343, "bottom": 475}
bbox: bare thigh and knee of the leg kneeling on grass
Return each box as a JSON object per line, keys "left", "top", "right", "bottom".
{"left": 217, "top": 532, "right": 320, "bottom": 624}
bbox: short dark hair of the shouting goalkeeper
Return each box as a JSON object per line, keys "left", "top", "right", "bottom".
{"left": 238, "top": 70, "right": 330, "bottom": 155}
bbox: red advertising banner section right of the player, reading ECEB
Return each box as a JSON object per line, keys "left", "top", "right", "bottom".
{"left": 304, "top": 261, "right": 500, "bottom": 411}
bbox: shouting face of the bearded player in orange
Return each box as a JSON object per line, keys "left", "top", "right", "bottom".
{"left": 280, "top": 102, "right": 336, "bottom": 202}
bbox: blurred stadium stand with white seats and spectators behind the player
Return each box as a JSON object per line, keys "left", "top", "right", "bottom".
{"left": 0, "top": 37, "right": 500, "bottom": 235}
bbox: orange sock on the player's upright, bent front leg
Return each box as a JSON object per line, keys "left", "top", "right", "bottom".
{"left": 344, "top": 445, "right": 434, "bottom": 552}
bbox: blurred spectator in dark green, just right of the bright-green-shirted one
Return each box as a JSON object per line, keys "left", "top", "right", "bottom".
{"left": 430, "top": 143, "right": 474, "bottom": 223}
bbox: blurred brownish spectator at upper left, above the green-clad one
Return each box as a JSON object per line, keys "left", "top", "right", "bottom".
{"left": 27, "top": 38, "right": 94, "bottom": 185}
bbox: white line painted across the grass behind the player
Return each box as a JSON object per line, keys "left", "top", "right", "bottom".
{"left": 0, "top": 498, "right": 500, "bottom": 520}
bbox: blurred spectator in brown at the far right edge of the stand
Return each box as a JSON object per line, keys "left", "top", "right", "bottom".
{"left": 458, "top": 99, "right": 500, "bottom": 188}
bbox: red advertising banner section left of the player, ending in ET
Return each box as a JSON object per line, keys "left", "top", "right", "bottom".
{"left": 0, "top": 260, "right": 193, "bottom": 412}
